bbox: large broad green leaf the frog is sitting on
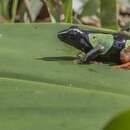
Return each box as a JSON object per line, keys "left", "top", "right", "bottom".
{"left": 0, "top": 24, "right": 130, "bottom": 130}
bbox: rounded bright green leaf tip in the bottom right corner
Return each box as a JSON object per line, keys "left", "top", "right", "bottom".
{"left": 104, "top": 111, "right": 130, "bottom": 130}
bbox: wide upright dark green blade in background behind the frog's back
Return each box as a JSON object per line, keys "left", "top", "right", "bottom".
{"left": 101, "top": 0, "right": 117, "bottom": 29}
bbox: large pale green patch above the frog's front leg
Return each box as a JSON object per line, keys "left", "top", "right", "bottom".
{"left": 89, "top": 33, "right": 114, "bottom": 55}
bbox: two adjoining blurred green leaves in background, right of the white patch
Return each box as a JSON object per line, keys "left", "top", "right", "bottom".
{"left": 81, "top": 0, "right": 117, "bottom": 29}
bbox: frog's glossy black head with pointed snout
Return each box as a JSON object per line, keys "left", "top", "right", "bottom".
{"left": 57, "top": 26, "right": 90, "bottom": 51}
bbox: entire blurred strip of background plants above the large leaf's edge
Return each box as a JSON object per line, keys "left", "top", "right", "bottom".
{"left": 0, "top": 0, "right": 130, "bottom": 29}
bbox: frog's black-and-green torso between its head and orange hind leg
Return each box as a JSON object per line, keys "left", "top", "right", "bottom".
{"left": 88, "top": 33, "right": 126, "bottom": 62}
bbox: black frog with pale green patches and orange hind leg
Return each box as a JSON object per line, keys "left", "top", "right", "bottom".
{"left": 57, "top": 26, "right": 130, "bottom": 69}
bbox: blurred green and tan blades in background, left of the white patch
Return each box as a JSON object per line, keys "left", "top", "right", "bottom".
{"left": 0, "top": 0, "right": 72, "bottom": 23}
